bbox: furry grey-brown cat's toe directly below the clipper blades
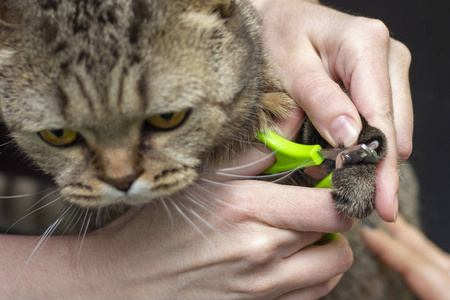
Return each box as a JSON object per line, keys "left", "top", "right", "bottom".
{"left": 332, "top": 164, "right": 376, "bottom": 219}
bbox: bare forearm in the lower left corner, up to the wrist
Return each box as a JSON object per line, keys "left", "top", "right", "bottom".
{"left": 0, "top": 235, "right": 104, "bottom": 299}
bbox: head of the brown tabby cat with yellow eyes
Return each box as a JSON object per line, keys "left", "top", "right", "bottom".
{"left": 0, "top": 0, "right": 268, "bottom": 207}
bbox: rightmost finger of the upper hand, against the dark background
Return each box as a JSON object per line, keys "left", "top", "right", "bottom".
{"left": 389, "top": 38, "right": 414, "bottom": 162}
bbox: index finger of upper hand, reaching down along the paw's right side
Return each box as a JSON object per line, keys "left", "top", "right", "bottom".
{"left": 332, "top": 18, "right": 399, "bottom": 221}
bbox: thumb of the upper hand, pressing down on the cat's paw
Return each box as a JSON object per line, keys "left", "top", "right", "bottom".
{"left": 260, "top": 1, "right": 362, "bottom": 147}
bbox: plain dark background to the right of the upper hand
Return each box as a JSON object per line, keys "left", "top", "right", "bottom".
{"left": 321, "top": 0, "right": 450, "bottom": 252}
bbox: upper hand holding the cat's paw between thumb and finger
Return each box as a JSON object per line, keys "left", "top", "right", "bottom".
{"left": 251, "top": 0, "right": 413, "bottom": 221}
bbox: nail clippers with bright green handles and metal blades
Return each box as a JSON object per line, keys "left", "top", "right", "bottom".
{"left": 256, "top": 131, "right": 380, "bottom": 245}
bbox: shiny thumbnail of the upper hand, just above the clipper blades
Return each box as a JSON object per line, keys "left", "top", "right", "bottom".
{"left": 330, "top": 115, "right": 361, "bottom": 147}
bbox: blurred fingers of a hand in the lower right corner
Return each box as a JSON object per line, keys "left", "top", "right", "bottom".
{"left": 362, "top": 217, "right": 450, "bottom": 300}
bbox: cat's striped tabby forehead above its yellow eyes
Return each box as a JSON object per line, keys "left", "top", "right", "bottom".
{"left": 0, "top": 0, "right": 255, "bottom": 130}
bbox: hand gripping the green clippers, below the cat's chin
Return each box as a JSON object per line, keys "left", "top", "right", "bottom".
{"left": 74, "top": 111, "right": 353, "bottom": 299}
